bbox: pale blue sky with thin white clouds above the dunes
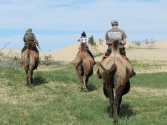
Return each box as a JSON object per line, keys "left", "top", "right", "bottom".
{"left": 0, "top": 0, "right": 167, "bottom": 52}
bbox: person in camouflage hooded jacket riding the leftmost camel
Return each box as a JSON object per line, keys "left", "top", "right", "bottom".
{"left": 21, "top": 28, "right": 40, "bottom": 53}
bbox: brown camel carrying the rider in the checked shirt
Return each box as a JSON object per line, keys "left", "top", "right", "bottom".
{"left": 72, "top": 43, "right": 94, "bottom": 91}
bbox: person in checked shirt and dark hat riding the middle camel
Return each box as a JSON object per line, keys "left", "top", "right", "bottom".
{"left": 78, "top": 31, "right": 96, "bottom": 65}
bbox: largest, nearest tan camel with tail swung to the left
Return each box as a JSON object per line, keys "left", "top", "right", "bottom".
{"left": 99, "top": 40, "right": 132, "bottom": 125}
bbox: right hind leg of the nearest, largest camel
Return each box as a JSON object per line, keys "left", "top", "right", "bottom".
{"left": 113, "top": 85, "right": 124, "bottom": 125}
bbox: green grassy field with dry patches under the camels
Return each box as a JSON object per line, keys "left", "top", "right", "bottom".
{"left": 0, "top": 61, "right": 167, "bottom": 125}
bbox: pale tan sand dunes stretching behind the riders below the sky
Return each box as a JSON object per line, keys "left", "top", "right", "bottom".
{"left": 0, "top": 40, "right": 167, "bottom": 62}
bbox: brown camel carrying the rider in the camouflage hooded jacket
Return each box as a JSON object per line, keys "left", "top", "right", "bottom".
{"left": 21, "top": 42, "right": 39, "bottom": 87}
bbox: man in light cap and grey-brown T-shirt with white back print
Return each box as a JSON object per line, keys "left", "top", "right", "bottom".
{"left": 97, "top": 20, "right": 136, "bottom": 76}
